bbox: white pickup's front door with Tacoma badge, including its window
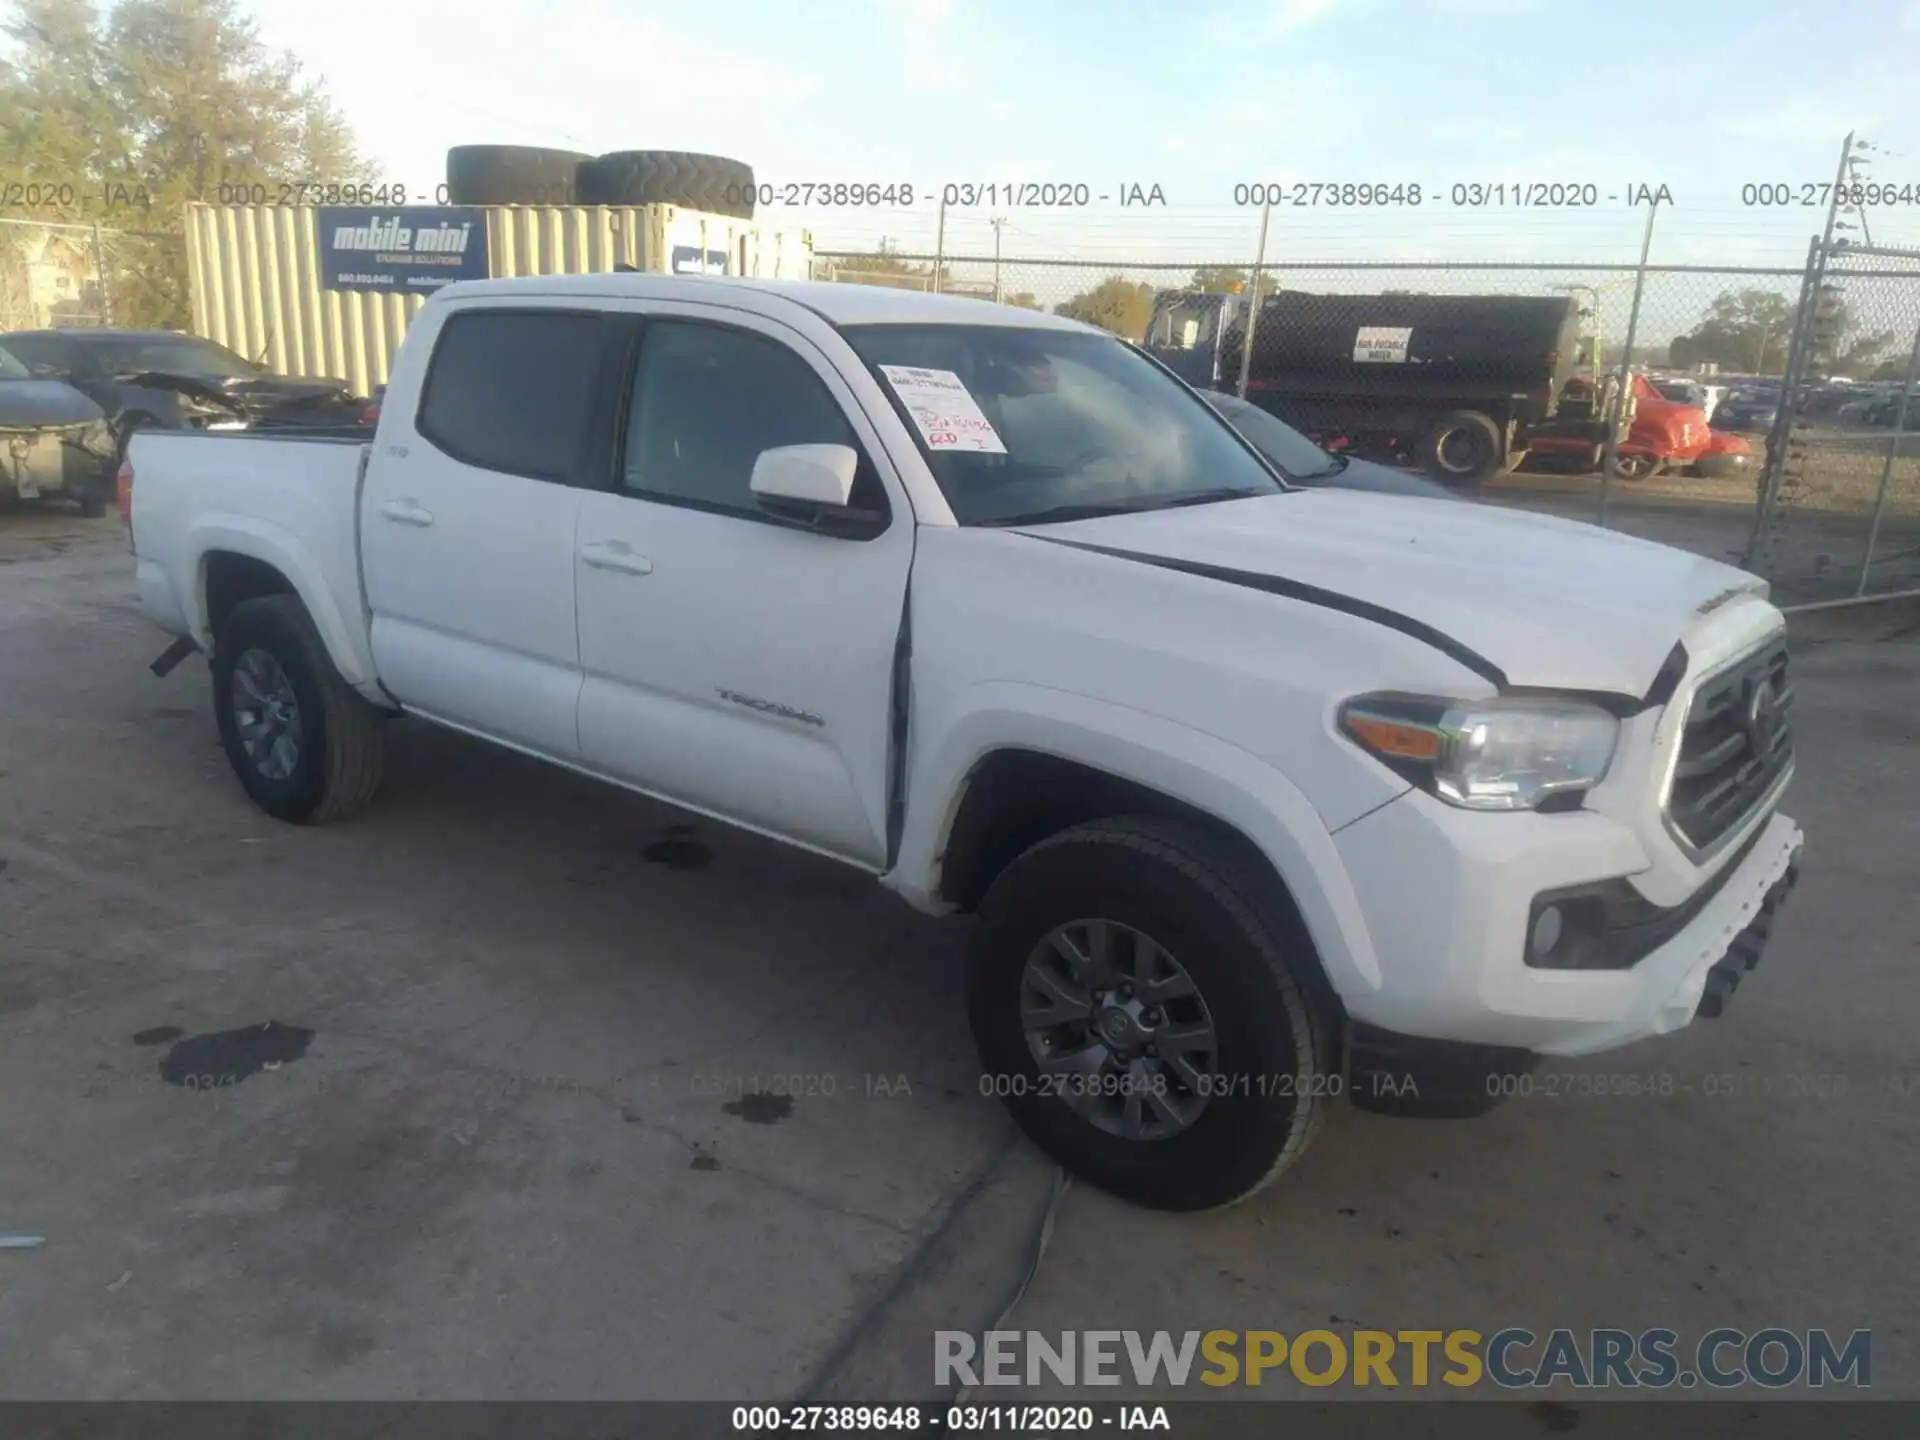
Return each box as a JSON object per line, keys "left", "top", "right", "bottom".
{"left": 578, "top": 305, "right": 914, "bottom": 870}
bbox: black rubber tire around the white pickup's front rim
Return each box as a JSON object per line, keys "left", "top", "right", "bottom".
{"left": 968, "top": 818, "right": 1340, "bottom": 1210}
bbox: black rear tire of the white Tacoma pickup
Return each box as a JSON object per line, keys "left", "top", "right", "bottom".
{"left": 209, "top": 595, "right": 384, "bottom": 826}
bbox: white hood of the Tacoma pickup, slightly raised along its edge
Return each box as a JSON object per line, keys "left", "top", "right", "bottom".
{"left": 1020, "top": 490, "right": 1766, "bottom": 699}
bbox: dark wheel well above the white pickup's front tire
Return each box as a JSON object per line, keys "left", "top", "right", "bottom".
{"left": 939, "top": 749, "right": 1346, "bottom": 1023}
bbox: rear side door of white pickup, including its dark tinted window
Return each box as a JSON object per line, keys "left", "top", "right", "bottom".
{"left": 361, "top": 303, "right": 622, "bottom": 760}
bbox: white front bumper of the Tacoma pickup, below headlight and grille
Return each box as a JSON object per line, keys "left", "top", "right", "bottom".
{"left": 1334, "top": 793, "right": 1803, "bottom": 1056}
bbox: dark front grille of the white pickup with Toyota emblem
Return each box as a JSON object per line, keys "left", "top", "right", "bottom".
{"left": 1667, "top": 639, "right": 1793, "bottom": 851}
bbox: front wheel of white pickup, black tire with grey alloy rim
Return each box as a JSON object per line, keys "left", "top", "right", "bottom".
{"left": 968, "top": 818, "right": 1340, "bottom": 1210}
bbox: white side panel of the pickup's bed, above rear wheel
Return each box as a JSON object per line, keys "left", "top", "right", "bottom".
{"left": 127, "top": 426, "right": 382, "bottom": 699}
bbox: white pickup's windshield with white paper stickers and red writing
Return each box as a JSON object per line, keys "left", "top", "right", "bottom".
{"left": 847, "top": 324, "right": 1284, "bottom": 524}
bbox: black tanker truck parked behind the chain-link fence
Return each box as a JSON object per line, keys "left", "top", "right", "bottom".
{"left": 1144, "top": 290, "right": 1592, "bottom": 486}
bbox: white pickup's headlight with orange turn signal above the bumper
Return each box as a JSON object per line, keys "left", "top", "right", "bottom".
{"left": 1340, "top": 695, "right": 1620, "bottom": 810}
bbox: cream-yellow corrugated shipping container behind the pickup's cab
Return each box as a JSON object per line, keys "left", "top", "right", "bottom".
{"left": 186, "top": 204, "right": 814, "bottom": 396}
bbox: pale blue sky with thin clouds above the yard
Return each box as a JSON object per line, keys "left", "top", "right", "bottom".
{"left": 252, "top": 0, "right": 1920, "bottom": 265}
